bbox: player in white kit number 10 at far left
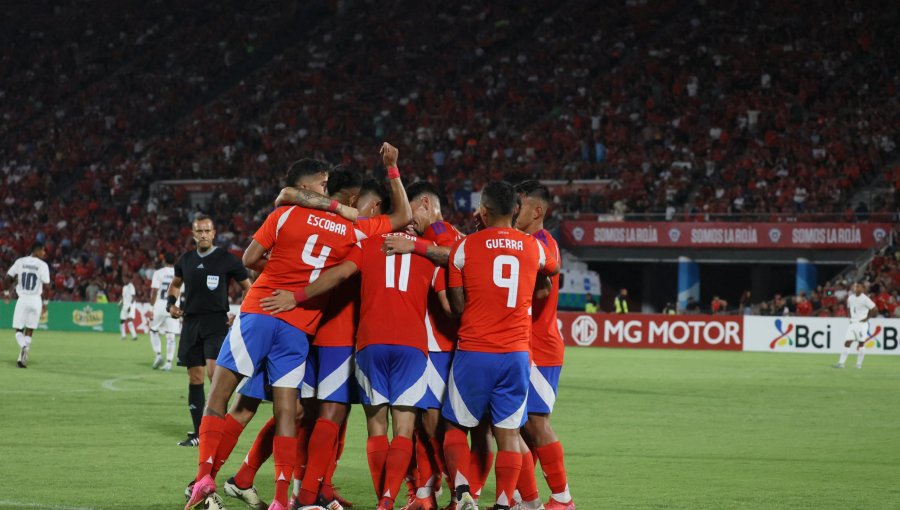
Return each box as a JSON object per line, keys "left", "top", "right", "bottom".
{"left": 3, "top": 243, "right": 50, "bottom": 368}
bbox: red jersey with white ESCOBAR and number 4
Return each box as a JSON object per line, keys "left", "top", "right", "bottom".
{"left": 241, "top": 206, "right": 357, "bottom": 335}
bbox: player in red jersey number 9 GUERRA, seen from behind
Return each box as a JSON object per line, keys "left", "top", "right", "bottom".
{"left": 442, "top": 182, "right": 559, "bottom": 510}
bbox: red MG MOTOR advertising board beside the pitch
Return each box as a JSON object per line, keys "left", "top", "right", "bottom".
{"left": 558, "top": 312, "right": 743, "bottom": 351}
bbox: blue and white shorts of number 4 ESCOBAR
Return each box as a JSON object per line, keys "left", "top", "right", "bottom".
{"left": 216, "top": 313, "right": 309, "bottom": 388}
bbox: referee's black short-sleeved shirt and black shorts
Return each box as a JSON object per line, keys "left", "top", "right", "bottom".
{"left": 175, "top": 246, "right": 249, "bottom": 368}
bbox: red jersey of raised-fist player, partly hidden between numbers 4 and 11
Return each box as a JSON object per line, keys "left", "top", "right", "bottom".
{"left": 313, "top": 214, "right": 393, "bottom": 347}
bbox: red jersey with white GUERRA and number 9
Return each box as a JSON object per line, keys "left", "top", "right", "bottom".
{"left": 449, "top": 227, "right": 558, "bottom": 353}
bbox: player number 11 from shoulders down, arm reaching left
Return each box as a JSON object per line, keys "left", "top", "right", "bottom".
{"left": 260, "top": 228, "right": 436, "bottom": 510}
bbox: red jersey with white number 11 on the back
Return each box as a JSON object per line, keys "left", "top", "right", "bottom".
{"left": 356, "top": 232, "right": 436, "bottom": 353}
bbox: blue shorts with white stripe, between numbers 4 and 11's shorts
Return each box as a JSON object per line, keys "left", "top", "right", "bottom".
{"left": 301, "top": 346, "right": 359, "bottom": 404}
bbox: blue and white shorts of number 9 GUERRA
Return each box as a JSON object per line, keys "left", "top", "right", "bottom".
{"left": 441, "top": 351, "right": 529, "bottom": 429}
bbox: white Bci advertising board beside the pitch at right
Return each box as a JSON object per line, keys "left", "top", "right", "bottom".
{"left": 744, "top": 316, "right": 900, "bottom": 355}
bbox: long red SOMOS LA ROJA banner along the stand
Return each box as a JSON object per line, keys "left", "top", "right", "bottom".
{"left": 562, "top": 221, "right": 891, "bottom": 250}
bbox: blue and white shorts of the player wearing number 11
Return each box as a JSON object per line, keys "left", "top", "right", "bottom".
{"left": 356, "top": 344, "right": 428, "bottom": 407}
